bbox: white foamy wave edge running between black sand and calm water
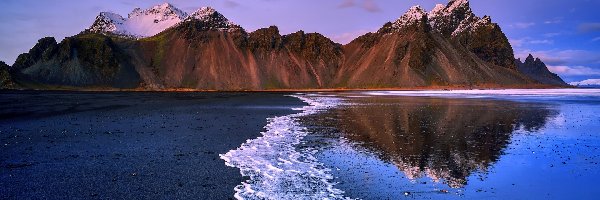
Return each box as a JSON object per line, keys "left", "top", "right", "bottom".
{"left": 220, "top": 95, "right": 345, "bottom": 199}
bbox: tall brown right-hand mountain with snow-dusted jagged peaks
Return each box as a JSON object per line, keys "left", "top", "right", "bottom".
{"left": 336, "top": 1, "right": 533, "bottom": 88}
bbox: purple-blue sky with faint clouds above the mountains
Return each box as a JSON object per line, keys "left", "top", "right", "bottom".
{"left": 0, "top": 0, "right": 600, "bottom": 82}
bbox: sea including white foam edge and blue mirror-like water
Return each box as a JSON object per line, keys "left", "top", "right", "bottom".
{"left": 220, "top": 89, "right": 600, "bottom": 199}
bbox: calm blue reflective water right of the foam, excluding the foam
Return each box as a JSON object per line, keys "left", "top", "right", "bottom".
{"left": 298, "top": 90, "right": 600, "bottom": 199}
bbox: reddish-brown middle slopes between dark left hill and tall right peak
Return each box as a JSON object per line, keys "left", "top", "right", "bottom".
{"left": 129, "top": 20, "right": 341, "bottom": 90}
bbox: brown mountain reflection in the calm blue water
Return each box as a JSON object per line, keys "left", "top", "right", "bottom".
{"left": 306, "top": 97, "right": 558, "bottom": 188}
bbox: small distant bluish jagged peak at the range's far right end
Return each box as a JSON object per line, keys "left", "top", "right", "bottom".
{"left": 515, "top": 54, "right": 569, "bottom": 86}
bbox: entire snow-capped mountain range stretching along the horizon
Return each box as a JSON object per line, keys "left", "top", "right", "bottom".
{"left": 0, "top": 0, "right": 568, "bottom": 90}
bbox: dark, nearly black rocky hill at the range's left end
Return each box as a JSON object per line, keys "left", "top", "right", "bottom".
{"left": 11, "top": 34, "right": 139, "bottom": 88}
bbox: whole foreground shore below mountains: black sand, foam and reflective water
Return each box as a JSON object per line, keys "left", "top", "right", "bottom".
{"left": 0, "top": 89, "right": 600, "bottom": 199}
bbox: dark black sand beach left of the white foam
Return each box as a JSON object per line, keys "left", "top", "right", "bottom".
{"left": 0, "top": 91, "right": 304, "bottom": 199}
